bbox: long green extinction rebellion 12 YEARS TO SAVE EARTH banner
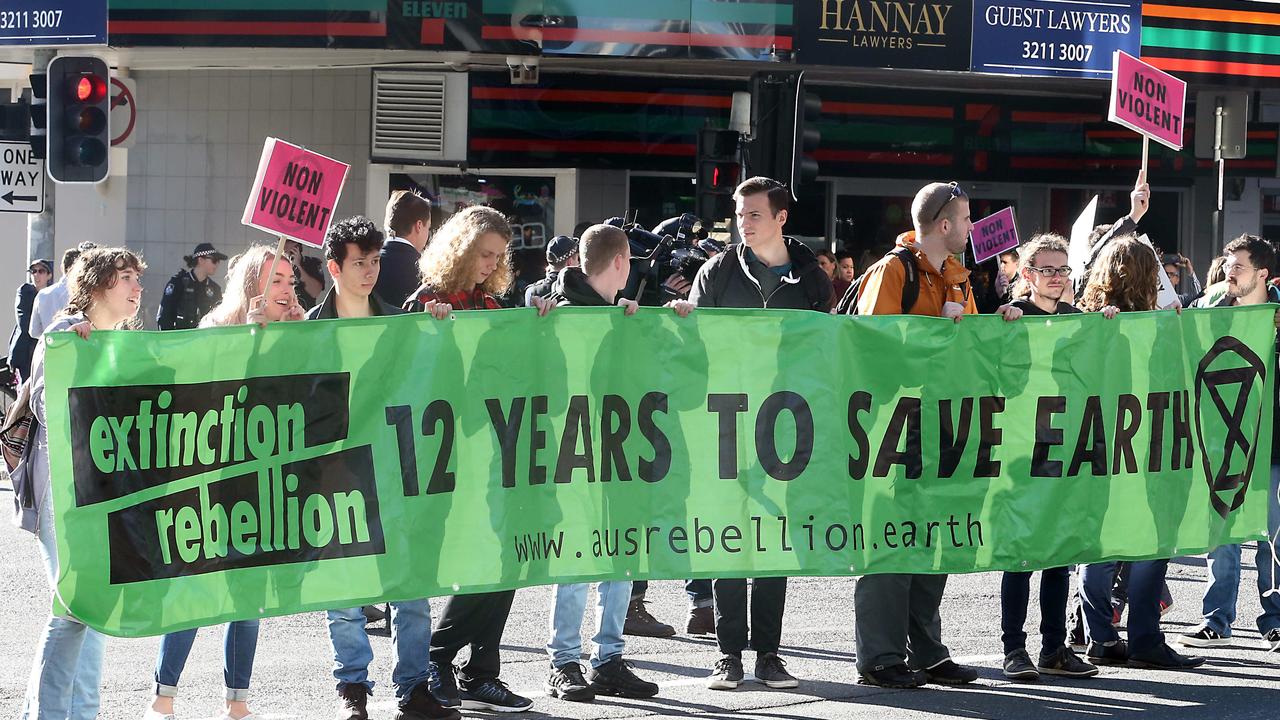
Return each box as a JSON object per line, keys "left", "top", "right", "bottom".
{"left": 47, "top": 306, "right": 1275, "bottom": 635}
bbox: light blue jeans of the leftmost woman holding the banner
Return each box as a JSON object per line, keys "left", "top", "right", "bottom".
{"left": 19, "top": 481, "right": 106, "bottom": 720}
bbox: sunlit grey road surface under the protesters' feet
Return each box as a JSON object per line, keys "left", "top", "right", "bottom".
{"left": 0, "top": 488, "right": 1280, "bottom": 720}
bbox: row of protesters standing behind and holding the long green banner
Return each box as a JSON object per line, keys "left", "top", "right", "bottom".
{"left": 12, "top": 177, "right": 1280, "bottom": 720}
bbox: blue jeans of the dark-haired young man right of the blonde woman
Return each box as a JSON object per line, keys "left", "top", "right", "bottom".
{"left": 329, "top": 598, "right": 431, "bottom": 703}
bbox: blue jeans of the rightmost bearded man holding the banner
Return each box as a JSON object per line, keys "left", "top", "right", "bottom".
{"left": 1203, "top": 465, "right": 1280, "bottom": 637}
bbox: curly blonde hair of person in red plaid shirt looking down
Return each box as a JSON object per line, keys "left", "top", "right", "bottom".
{"left": 419, "top": 205, "right": 511, "bottom": 296}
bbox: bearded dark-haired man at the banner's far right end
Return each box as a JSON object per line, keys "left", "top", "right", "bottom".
{"left": 1178, "top": 234, "right": 1280, "bottom": 650}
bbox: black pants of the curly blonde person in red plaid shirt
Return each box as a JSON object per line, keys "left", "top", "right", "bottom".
{"left": 431, "top": 591, "right": 516, "bottom": 684}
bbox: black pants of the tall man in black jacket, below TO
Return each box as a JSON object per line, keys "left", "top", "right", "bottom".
{"left": 712, "top": 578, "right": 787, "bottom": 655}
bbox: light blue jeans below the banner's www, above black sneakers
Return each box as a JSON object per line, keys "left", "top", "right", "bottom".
{"left": 547, "top": 580, "right": 631, "bottom": 667}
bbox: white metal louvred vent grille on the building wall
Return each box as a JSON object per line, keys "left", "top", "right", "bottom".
{"left": 371, "top": 70, "right": 466, "bottom": 161}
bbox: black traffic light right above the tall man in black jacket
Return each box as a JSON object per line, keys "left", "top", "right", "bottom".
{"left": 749, "top": 72, "right": 822, "bottom": 199}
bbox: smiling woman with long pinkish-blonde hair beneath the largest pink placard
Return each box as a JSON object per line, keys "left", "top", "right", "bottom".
{"left": 142, "top": 245, "right": 302, "bottom": 720}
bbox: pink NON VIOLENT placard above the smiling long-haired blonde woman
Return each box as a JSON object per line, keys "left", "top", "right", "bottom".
{"left": 241, "top": 137, "right": 348, "bottom": 247}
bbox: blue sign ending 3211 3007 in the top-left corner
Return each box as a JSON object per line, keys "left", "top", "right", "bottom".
{"left": 0, "top": 0, "right": 108, "bottom": 47}
